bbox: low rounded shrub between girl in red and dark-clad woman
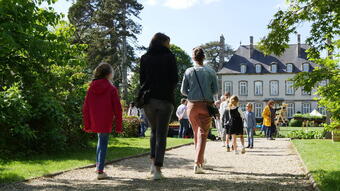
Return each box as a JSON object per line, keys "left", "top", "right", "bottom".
{"left": 112, "top": 116, "right": 140, "bottom": 137}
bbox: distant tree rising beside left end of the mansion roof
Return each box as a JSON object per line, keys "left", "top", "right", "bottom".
{"left": 201, "top": 41, "right": 234, "bottom": 72}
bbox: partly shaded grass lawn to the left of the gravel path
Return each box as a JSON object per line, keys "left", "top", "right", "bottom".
{"left": 0, "top": 137, "right": 192, "bottom": 184}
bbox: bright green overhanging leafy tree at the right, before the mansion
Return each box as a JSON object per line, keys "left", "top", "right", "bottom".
{"left": 260, "top": 0, "right": 340, "bottom": 127}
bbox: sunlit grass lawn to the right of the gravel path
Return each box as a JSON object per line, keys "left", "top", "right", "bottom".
{"left": 292, "top": 139, "right": 340, "bottom": 191}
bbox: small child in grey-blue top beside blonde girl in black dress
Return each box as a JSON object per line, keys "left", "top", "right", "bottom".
{"left": 244, "top": 103, "right": 256, "bottom": 149}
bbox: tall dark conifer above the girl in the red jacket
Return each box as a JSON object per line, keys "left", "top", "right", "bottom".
{"left": 69, "top": 0, "right": 143, "bottom": 97}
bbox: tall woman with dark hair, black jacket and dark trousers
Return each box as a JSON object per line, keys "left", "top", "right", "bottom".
{"left": 140, "top": 33, "right": 178, "bottom": 180}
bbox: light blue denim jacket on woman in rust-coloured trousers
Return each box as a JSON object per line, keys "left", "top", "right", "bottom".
{"left": 181, "top": 65, "right": 218, "bottom": 101}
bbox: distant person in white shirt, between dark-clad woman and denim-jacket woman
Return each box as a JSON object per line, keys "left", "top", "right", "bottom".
{"left": 176, "top": 98, "right": 190, "bottom": 138}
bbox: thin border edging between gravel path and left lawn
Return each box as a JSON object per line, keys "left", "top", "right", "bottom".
{"left": 0, "top": 142, "right": 194, "bottom": 185}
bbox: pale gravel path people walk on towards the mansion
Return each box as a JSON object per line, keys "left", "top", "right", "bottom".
{"left": 0, "top": 139, "right": 313, "bottom": 191}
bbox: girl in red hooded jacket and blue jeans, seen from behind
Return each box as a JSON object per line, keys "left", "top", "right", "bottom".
{"left": 83, "top": 63, "right": 122, "bottom": 180}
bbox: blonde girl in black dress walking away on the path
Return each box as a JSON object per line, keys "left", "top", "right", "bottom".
{"left": 223, "top": 96, "right": 246, "bottom": 154}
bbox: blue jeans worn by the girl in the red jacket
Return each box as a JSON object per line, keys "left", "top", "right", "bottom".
{"left": 96, "top": 133, "right": 109, "bottom": 172}
